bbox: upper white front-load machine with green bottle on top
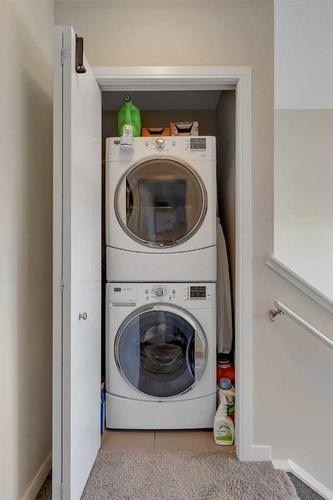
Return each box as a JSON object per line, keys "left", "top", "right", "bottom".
{"left": 106, "top": 136, "right": 216, "bottom": 282}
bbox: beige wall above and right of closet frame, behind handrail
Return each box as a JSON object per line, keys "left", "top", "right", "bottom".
{"left": 56, "top": 0, "right": 333, "bottom": 488}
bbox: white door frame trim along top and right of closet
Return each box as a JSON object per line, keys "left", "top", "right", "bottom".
{"left": 93, "top": 66, "right": 271, "bottom": 460}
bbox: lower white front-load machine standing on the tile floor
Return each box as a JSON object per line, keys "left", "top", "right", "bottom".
{"left": 106, "top": 283, "right": 216, "bottom": 429}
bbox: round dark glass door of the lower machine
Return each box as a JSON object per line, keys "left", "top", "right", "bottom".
{"left": 115, "top": 305, "right": 207, "bottom": 398}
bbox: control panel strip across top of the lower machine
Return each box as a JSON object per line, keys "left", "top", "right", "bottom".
{"left": 106, "top": 283, "right": 215, "bottom": 309}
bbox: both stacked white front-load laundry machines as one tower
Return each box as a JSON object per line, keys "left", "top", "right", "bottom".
{"left": 106, "top": 136, "right": 216, "bottom": 429}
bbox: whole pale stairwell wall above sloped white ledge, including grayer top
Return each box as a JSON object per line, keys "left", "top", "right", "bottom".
{"left": 274, "top": 0, "right": 333, "bottom": 299}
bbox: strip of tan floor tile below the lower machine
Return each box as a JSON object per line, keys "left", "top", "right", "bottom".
{"left": 102, "top": 430, "right": 235, "bottom": 453}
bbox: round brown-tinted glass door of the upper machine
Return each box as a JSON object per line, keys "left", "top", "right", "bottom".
{"left": 114, "top": 157, "right": 207, "bottom": 247}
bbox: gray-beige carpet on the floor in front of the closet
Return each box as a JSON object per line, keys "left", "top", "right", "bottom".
{"left": 37, "top": 451, "right": 304, "bottom": 500}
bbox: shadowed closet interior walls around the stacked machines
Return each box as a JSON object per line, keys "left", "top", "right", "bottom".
{"left": 101, "top": 89, "right": 237, "bottom": 448}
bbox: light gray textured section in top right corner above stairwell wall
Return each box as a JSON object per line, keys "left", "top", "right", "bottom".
{"left": 275, "top": 0, "right": 333, "bottom": 109}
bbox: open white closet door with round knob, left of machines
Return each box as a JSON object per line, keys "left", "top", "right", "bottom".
{"left": 52, "top": 26, "right": 101, "bottom": 500}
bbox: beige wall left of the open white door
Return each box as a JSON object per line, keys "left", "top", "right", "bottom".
{"left": 0, "top": 0, "right": 54, "bottom": 500}
